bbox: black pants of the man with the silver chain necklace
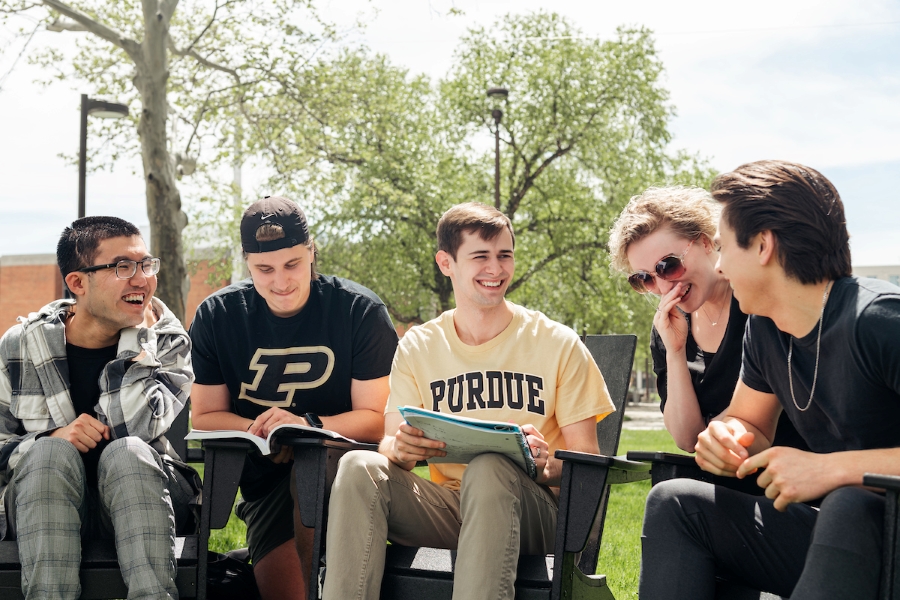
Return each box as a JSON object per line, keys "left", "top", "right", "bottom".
{"left": 640, "top": 479, "right": 884, "bottom": 600}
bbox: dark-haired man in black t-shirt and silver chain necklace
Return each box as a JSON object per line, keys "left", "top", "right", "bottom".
{"left": 640, "top": 161, "right": 900, "bottom": 600}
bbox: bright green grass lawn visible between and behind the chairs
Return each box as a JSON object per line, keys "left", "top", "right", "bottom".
{"left": 199, "top": 430, "right": 679, "bottom": 600}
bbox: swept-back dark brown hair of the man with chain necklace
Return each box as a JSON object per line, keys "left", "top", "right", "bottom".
{"left": 710, "top": 160, "right": 851, "bottom": 284}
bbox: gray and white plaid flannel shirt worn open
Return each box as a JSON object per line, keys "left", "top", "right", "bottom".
{"left": 0, "top": 298, "right": 194, "bottom": 538}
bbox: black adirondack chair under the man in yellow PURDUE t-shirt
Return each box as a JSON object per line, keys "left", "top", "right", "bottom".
{"left": 381, "top": 335, "right": 649, "bottom": 600}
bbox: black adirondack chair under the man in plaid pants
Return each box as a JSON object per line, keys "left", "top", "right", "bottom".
{"left": 0, "top": 408, "right": 204, "bottom": 600}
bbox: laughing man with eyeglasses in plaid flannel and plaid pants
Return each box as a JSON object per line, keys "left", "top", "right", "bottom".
{"left": 0, "top": 217, "right": 199, "bottom": 599}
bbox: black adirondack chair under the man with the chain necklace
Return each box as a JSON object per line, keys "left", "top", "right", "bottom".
{"left": 628, "top": 451, "right": 900, "bottom": 600}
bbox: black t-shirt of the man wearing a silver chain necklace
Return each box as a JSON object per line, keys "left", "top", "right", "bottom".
{"left": 741, "top": 277, "right": 900, "bottom": 453}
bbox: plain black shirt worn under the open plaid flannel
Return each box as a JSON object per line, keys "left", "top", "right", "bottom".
{"left": 66, "top": 343, "right": 118, "bottom": 485}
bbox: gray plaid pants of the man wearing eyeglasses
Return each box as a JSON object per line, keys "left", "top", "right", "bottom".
{"left": 6, "top": 437, "right": 192, "bottom": 600}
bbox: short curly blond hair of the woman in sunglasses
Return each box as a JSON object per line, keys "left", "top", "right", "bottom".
{"left": 609, "top": 185, "right": 721, "bottom": 273}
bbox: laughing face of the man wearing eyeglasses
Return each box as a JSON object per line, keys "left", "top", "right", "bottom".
{"left": 66, "top": 235, "right": 156, "bottom": 347}
